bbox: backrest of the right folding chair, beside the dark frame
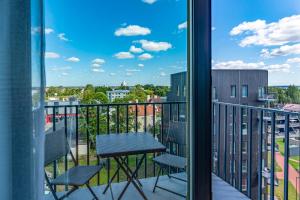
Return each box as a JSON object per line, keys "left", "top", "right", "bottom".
{"left": 166, "top": 121, "right": 187, "bottom": 146}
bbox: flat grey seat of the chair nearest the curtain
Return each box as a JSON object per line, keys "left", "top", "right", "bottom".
{"left": 51, "top": 165, "right": 103, "bottom": 186}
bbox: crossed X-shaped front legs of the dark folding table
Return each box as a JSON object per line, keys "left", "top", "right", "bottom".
{"left": 114, "top": 157, "right": 147, "bottom": 200}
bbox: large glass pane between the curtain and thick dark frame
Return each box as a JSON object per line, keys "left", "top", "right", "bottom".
{"left": 45, "top": 0, "right": 189, "bottom": 199}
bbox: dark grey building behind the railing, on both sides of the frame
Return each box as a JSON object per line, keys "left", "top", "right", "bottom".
{"left": 168, "top": 69, "right": 275, "bottom": 199}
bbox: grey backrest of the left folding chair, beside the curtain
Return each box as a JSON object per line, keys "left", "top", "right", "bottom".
{"left": 44, "top": 129, "right": 70, "bottom": 166}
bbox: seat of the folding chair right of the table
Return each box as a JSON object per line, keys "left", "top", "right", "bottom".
{"left": 153, "top": 153, "right": 187, "bottom": 169}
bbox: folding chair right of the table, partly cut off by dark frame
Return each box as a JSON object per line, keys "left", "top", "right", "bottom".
{"left": 153, "top": 121, "right": 187, "bottom": 197}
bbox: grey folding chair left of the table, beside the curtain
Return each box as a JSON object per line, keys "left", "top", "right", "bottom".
{"left": 44, "top": 129, "right": 104, "bottom": 200}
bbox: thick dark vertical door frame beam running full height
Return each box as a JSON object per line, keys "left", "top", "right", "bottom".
{"left": 188, "top": 0, "right": 212, "bottom": 200}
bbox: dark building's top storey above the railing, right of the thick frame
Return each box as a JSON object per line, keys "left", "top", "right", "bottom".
{"left": 212, "top": 69, "right": 275, "bottom": 106}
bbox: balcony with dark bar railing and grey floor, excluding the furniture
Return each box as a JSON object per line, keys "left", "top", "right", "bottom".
{"left": 45, "top": 102, "right": 300, "bottom": 200}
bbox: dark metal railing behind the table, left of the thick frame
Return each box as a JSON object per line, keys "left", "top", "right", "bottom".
{"left": 45, "top": 102, "right": 186, "bottom": 191}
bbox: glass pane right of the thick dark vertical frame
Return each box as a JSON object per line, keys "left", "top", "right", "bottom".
{"left": 211, "top": 0, "right": 300, "bottom": 200}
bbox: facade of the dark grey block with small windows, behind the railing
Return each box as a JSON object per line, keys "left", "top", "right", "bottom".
{"left": 168, "top": 69, "right": 274, "bottom": 199}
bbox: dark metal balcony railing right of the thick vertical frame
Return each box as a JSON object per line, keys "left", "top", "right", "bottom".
{"left": 212, "top": 102, "right": 300, "bottom": 199}
